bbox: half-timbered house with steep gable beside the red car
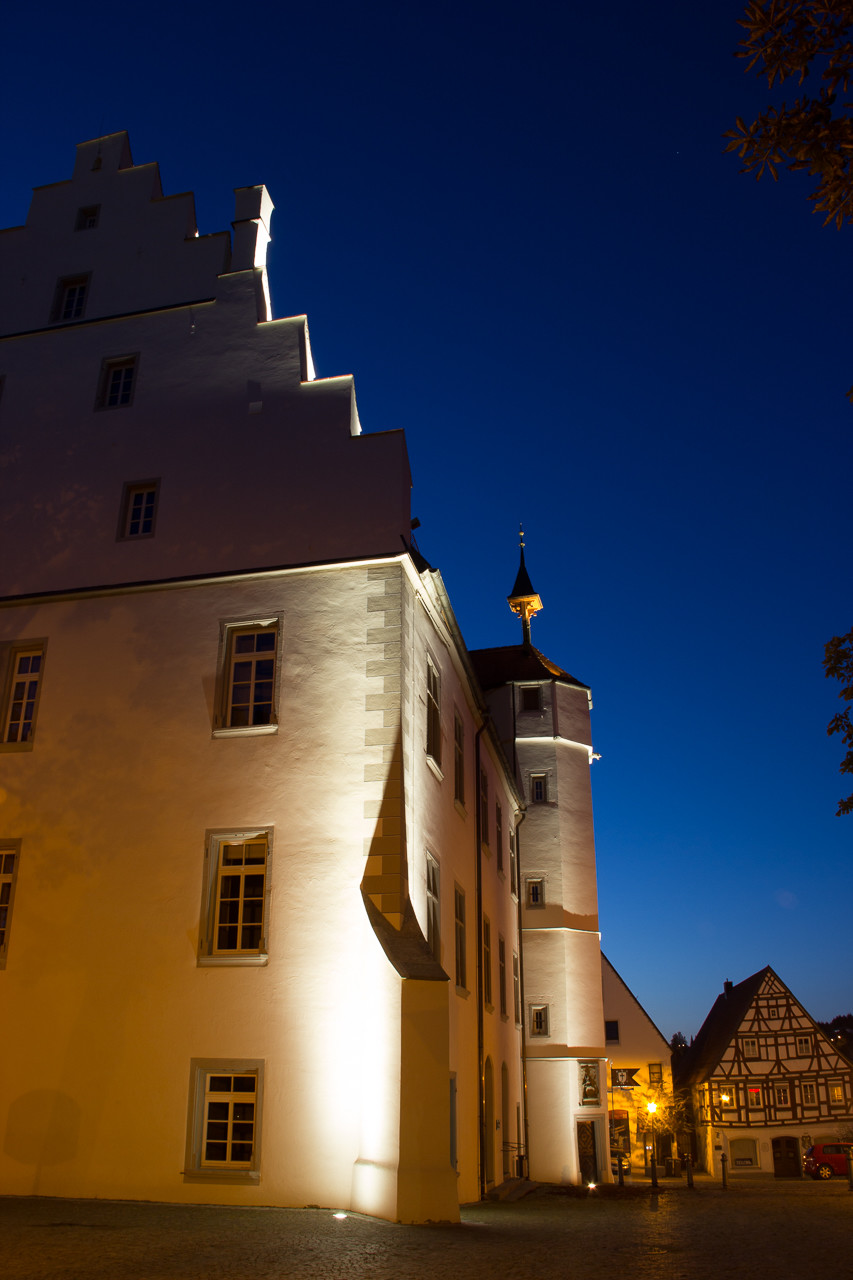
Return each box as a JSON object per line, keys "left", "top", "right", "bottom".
{"left": 676, "top": 966, "right": 853, "bottom": 1176}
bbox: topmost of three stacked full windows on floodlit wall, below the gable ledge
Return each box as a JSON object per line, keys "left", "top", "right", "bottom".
{"left": 214, "top": 618, "right": 280, "bottom": 733}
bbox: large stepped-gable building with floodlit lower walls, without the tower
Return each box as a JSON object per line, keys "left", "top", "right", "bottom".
{"left": 0, "top": 134, "right": 525, "bottom": 1221}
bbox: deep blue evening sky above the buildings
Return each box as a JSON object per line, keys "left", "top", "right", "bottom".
{"left": 0, "top": 0, "right": 853, "bottom": 1038}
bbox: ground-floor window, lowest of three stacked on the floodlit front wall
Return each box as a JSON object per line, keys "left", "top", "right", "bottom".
{"left": 184, "top": 1059, "right": 264, "bottom": 1183}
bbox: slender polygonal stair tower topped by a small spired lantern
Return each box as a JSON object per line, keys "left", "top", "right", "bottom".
{"left": 471, "top": 563, "right": 611, "bottom": 1183}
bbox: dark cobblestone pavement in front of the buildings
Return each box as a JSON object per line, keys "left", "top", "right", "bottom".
{"left": 0, "top": 1178, "right": 853, "bottom": 1280}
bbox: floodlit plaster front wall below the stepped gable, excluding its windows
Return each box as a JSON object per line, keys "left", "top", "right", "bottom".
{"left": 0, "top": 568, "right": 425, "bottom": 1206}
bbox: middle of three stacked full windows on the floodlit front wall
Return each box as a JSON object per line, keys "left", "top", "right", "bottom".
{"left": 199, "top": 831, "right": 270, "bottom": 964}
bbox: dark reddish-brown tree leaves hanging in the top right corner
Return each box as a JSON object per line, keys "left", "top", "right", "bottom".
{"left": 724, "top": 0, "right": 853, "bottom": 228}
